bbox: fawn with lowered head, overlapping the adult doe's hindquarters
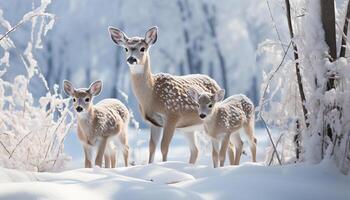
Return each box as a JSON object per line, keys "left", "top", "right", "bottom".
{"left": 188, "top": 88, "right": 257, "bottom": 167}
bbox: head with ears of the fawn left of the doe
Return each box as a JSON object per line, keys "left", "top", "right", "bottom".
{"left": 63, "top": 80, "right": 102, "bottom": 114}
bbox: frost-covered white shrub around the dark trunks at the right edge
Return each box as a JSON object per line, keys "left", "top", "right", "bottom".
{"left": 260, "top": 0, "right": 350, "bottom": 173}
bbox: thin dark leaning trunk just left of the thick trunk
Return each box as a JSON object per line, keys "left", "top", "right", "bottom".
{"left": 285, "top": 0, "right": 309, "bottom": 127}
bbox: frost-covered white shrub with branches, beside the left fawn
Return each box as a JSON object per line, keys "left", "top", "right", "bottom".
{"left": 0, "top": 0, "right": 73, "bottom": 171}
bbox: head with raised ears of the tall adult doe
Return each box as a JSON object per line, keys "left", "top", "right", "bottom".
{"left": 108, "top": 27, "right": 158, "bottom": 65}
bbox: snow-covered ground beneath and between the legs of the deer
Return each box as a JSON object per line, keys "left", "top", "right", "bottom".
{"left": 0, "top": 130, "right": 350, "bottom": 200}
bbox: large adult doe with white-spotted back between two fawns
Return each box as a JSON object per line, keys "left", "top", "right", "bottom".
{"left": 109, "top": 27, "right": 220, "bottom": 164}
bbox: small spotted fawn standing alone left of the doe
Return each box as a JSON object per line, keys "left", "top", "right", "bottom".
{"left": 63, "top": 80, "right": 130, "bottom": 168}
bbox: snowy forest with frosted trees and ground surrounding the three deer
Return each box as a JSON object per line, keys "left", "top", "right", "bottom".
{"left": 0, "top": 0, "right": 350, "bottom": 199}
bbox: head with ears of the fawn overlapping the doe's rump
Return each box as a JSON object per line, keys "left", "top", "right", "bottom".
{"left": 188, "top": 88, "right": 225, "bottom": 119}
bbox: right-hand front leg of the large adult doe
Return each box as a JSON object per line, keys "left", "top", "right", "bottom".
{"left": 160, "top": 117, "right": 177, "bottom": 162}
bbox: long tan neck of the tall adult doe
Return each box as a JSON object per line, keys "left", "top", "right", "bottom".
{"left": 129, "top": 54, "right": 154, "bottom": 105}
